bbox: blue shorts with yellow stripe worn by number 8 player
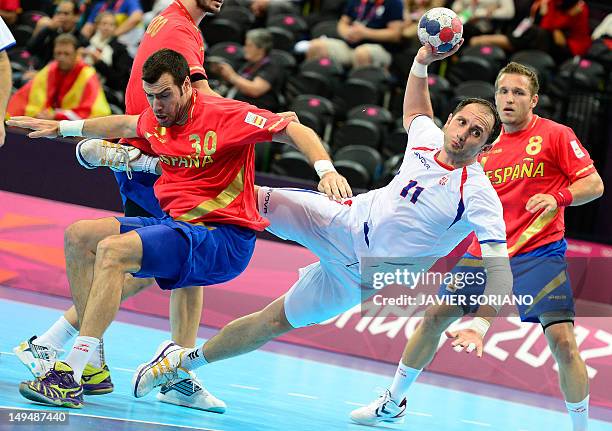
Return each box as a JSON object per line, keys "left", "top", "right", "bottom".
{"left": 438, "top": 239, "right": 574, "bottom": 322}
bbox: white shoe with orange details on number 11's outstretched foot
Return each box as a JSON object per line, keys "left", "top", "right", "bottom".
{"left": 132, "top": 341, "right": 186, "bottom": 398}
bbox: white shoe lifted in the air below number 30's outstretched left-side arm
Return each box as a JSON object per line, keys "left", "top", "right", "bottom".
{"left": 76, "top": 139, "right": 140, "bottom": 179}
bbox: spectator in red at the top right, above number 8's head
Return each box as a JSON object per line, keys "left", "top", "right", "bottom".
{"left": 470, "top": 0, "right": 591, "bottom": 63}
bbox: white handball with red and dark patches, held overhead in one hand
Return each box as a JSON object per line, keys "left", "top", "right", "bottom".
{"left": 418, "top": 7, "right": 463, "bottom": 52}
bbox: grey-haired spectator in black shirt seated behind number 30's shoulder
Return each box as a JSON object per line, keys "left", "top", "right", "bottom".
{"left": 212, "top": 28, "right": 284, "bottom": 111}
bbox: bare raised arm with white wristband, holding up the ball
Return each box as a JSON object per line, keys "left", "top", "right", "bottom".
{"left": 404, "top": 39, "right": 463, "bottom": 130}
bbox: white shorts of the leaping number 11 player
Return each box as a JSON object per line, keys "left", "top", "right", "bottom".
{"left": 258, "top": 187, "right": 361, "bottom": 328}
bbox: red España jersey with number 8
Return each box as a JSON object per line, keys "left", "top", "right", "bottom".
{"left": 468, "top": 115, "right": 595, "bottom": 256}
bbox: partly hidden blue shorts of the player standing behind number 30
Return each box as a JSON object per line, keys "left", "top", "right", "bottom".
{"left": 114, "top": 172, "right": 165, "bottom": 218}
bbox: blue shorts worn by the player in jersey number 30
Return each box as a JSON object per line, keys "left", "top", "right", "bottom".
{"left": 117, "top": 216, "right": 255, "bottom": 290}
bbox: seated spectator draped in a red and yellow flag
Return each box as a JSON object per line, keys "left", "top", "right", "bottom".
{"left": 7, "top": 34, "right": 111, "bottom": 120}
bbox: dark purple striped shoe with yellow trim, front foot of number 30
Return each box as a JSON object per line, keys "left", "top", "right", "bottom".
{"left": 19, "top": 361, "right": 83, "bottom": 409}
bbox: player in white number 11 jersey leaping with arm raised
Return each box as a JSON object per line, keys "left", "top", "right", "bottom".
{"left": 133, "top": 41, "right": 512, "bottom": 417}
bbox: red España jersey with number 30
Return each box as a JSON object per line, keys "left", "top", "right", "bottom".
{"left": 137, "top": 90, "right": 289, "bottom": 231}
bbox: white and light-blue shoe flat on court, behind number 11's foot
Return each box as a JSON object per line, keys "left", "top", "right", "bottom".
{"left": 157, "top": 370, "right": 226, "bottom": 413}
